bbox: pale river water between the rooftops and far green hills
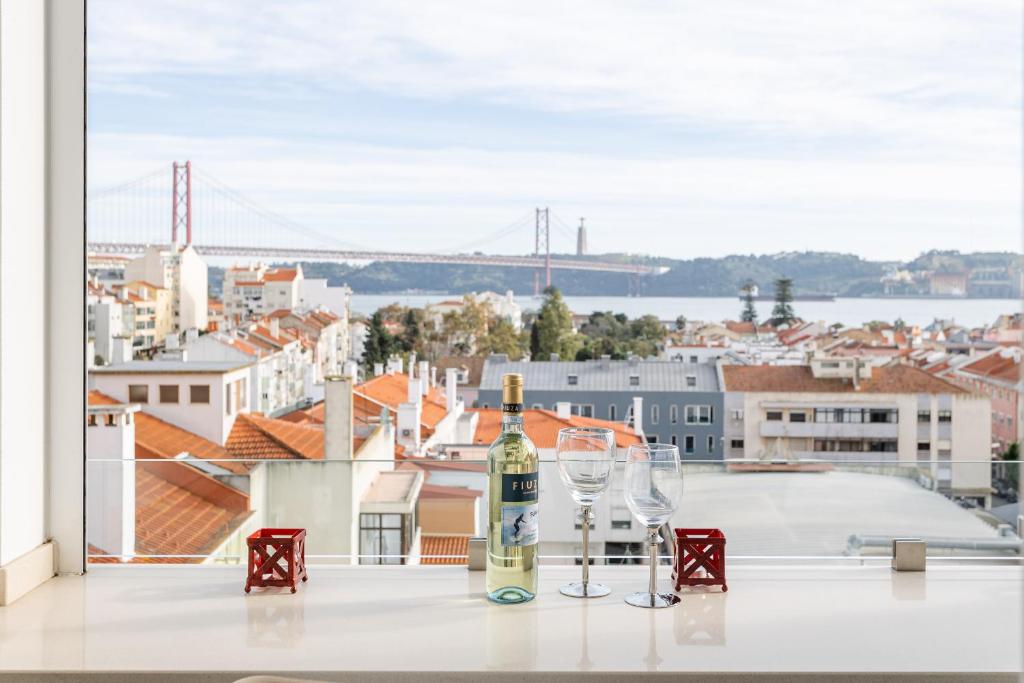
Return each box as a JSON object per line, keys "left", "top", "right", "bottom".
{"left": 352, "top": 294, "right": 1021, "bottom": 328}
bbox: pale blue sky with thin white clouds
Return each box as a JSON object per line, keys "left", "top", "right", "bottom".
{"left": 88, "top": 0, "right": 1022, "bottom": 260}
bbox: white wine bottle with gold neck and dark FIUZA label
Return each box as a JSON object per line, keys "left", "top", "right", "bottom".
{"left": 486, "top": 374, "right": 540, "bottom": 604}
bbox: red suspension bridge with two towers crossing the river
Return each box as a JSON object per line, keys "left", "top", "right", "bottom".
{"left": 86, "top": 162, "right": 664, "bottom": 291}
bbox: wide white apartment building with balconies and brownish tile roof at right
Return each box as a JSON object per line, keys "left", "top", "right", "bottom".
{"left": 719, "top": 357, "right": 991, "bottom": 501}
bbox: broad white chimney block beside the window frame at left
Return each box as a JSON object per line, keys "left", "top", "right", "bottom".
{"left": 86, "top": 405, "right": 138, "bottom": 562}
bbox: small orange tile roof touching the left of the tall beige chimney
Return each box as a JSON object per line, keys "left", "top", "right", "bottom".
{"left": 226, "top": 413, "right": 324, "bottom": 460}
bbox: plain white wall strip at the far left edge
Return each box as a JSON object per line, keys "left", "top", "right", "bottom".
{"left": 0, "top": 0, "right": 46, "bottom": 566}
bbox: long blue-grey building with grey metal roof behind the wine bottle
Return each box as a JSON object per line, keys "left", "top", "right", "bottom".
{"left": 476, "top": 355, "right": 727, "bottom": 460}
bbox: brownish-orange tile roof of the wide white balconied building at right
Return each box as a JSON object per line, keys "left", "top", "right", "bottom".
{"left": 722, "top": 365, "right": 967, "bottom": 393}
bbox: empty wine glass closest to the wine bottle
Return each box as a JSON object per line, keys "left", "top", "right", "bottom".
{"left": 555, "top": 427, "right": 615, "bottom": 598}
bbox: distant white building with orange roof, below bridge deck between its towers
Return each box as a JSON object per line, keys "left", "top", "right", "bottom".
{"left": 223, "top": 263, "right": 303, "bottom": 324}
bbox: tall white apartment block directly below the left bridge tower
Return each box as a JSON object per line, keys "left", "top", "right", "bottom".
{"left": 125, "top": 245, "right": 209, "bottom": 332}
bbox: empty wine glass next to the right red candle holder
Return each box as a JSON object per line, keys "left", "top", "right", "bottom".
{"left": 626, "top": 443, "right": 683, "bottom": 607}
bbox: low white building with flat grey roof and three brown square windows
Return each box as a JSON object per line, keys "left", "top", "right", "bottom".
{"left": 89, "top": 360, "right": 251, "bottom": 445}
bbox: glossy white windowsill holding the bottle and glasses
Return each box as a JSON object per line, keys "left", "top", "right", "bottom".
{"left": 0, "top": 565, "right": 1022, "bottom": 682}
